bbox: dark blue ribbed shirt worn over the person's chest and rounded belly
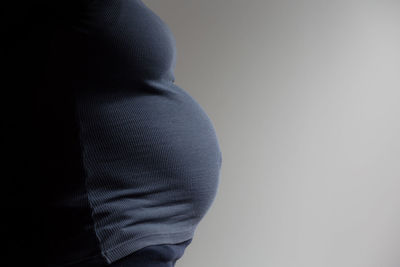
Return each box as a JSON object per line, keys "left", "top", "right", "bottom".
{"left": 2, "top": 0, "right": 222, "bottom": 266}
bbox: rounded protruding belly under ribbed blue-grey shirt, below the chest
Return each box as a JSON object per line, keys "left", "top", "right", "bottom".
{"left": 77, "top": 81, "right": 221, "bottom": 224}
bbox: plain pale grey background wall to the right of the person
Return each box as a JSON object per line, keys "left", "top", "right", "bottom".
{"left": 143, "top": 0, "right": 400, "bottom": 267}
